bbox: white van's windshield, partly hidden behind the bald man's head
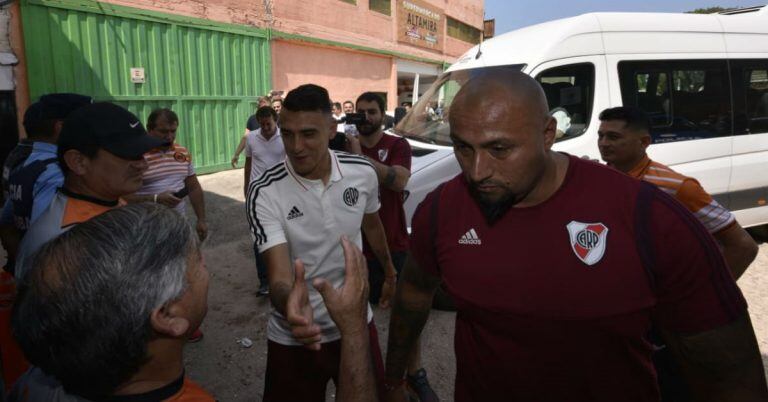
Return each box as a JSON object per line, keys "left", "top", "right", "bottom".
{"left": 395, "top": 64, "right": 525, "bottom": 146}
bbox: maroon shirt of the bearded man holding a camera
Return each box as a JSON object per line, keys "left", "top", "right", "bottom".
{"left": 361, "top": 134, "right": 411, "bottom": 260}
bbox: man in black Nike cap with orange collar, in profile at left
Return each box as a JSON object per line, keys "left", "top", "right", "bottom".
{"left": 15, "top": 102, "right": 166, "bottom": 280}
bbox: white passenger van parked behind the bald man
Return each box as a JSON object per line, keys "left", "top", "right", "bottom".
{"left": 395, "top": 6, "right": 768, "bottom": 227}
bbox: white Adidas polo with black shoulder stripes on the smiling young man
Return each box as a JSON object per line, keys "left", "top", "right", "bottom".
{"left": 246, "top": 151, "right": 379, "bottom": 345}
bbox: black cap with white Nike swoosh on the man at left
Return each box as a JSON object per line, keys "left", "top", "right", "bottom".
{"left": 58, "top": 102, "right": 169, "bottom": 160}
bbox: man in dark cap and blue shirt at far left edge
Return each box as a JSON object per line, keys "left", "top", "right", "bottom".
{"left": 0, "top": 93, "right": 92, "bottom": 272}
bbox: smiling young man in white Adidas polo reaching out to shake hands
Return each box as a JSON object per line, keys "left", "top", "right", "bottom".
{"left": 246, "top": 84, "right": 395, "bottom": 402}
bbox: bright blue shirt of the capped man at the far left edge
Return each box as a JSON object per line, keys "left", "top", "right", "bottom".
{"left": 0, "top": 141, "right": 64, "bottom": 224}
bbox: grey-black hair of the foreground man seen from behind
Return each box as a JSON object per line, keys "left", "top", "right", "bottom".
{"left": 12, "top": 204, "right": 199, "bottom": 399}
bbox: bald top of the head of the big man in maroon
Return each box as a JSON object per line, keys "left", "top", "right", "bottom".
{"left": 449, "top": 71, "right": 549, "bottom": 130}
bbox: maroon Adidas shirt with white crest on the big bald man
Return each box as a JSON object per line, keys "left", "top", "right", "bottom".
{"left": 411, "top": 157, "right": 746, "bottom": 402}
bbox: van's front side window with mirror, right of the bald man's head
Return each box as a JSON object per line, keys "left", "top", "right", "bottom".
{"left": 536, "top": 63, "right": 595, "bottom": 142}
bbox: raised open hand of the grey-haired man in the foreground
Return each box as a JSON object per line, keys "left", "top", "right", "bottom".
{"left": 312, "top": 236, "right": 368, "bottom": 337}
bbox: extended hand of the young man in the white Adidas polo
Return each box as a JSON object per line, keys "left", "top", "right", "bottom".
{"left": 285, "top": 258, "right": 330, "bottom": 350}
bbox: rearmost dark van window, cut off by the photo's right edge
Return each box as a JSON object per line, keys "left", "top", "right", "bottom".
{"left": 731, "top": 60, "right": 768, "bottom": 135}
